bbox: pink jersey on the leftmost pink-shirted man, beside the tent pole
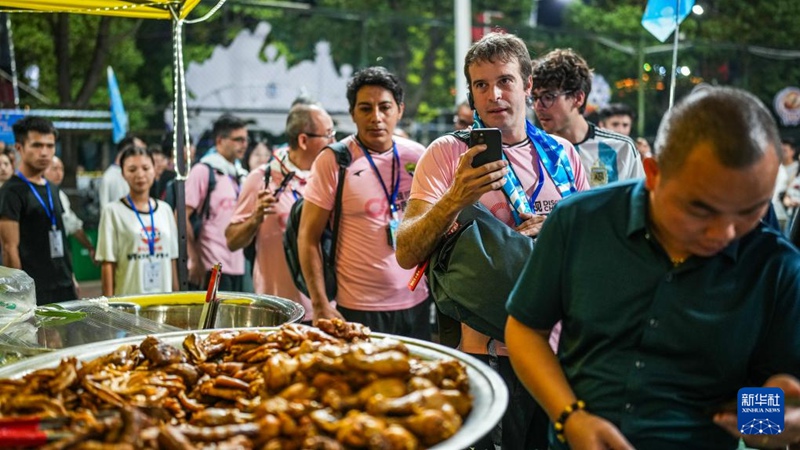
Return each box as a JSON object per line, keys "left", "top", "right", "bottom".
{"left": 186, "top": 164, "right": 244, "bottom": 275}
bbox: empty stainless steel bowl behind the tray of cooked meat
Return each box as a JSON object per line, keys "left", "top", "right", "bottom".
{"left": 101, "top": 291, "right": 305, "bottom": 330}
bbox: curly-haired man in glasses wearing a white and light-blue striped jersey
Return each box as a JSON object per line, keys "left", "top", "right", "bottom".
{"left": 531, "top": 49, "right": 644, "bottom": 186}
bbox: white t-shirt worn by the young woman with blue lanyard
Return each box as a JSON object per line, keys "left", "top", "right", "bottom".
{"left": 95, "top": 199, "right": 178, "bottom": 295}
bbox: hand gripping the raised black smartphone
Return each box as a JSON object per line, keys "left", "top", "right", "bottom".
{"left": 445, "top": 144, "right": 508, "bottom": 211}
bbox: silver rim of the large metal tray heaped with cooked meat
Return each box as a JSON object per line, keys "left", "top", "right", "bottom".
{"left": 0, "top": 328, "right": 508, "bottom": 450}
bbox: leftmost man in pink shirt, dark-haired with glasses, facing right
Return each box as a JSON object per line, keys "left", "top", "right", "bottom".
{"left": 186, "top": 114, "right": 247, "bottom": 291}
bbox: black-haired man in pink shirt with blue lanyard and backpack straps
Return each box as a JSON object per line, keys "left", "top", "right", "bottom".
{"left": 298, "top": 67, "right": 430, "bottom": 339}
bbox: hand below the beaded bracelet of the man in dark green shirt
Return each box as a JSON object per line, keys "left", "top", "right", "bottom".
{"left": 564, "top": 411, "right": 634, "bottom": 450}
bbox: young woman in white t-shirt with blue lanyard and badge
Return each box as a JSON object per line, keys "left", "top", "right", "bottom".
{"left": 96, "top": 146, "right": 178, "bottom": 296}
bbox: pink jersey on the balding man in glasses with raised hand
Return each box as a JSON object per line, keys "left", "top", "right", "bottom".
{"left": 231, "top": 149, "right": 313, "bottom": 320}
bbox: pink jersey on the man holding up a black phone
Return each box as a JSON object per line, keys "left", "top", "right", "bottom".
{"left": 410, "top": 135, "right": 589, "bottom": 355}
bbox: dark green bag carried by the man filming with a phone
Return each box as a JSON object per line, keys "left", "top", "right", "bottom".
{"left": 426, "top": 203, "right": 534, "bottom": 341}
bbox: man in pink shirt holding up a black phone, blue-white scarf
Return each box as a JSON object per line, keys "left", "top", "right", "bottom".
{"left": 397, "top": 33, "right": 589, "bottom": 450}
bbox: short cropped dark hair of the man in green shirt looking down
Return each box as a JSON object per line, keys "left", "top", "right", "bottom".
{"left": 654, "top": 87, "right": 783, "bottom": 177}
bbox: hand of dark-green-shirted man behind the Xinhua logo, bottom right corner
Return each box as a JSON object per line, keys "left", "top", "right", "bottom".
{"left": 714, "top": 374, "right": 800, "bottom": 450}
